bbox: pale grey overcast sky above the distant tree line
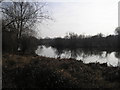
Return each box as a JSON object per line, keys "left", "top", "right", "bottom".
{"left": 38, "top": 0, "right": 119, "bottom": 37}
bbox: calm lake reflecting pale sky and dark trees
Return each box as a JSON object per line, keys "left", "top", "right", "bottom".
{"left": 35, "top": 45, "right": 120, "bottom": 67}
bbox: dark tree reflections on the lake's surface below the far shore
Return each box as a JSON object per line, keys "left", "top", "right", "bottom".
{"left": 55, "top": 48, "right": 111, "bottom": 59}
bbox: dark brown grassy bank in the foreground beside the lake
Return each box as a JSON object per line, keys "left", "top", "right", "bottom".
{"left": 2, "top": 54, "right": 120, "bottom": 89}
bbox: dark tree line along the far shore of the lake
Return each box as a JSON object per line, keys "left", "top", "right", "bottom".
{"left": 40, "top": 27, "right": 120, "bottom": 50}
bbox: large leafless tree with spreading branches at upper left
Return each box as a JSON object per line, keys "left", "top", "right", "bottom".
{"left": 1, "top": 0, "right": 51, "bottom": 51}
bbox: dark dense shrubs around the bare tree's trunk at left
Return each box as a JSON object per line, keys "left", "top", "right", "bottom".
{"left": 2, "top": 31, "right": 38, "bottom": 54}
